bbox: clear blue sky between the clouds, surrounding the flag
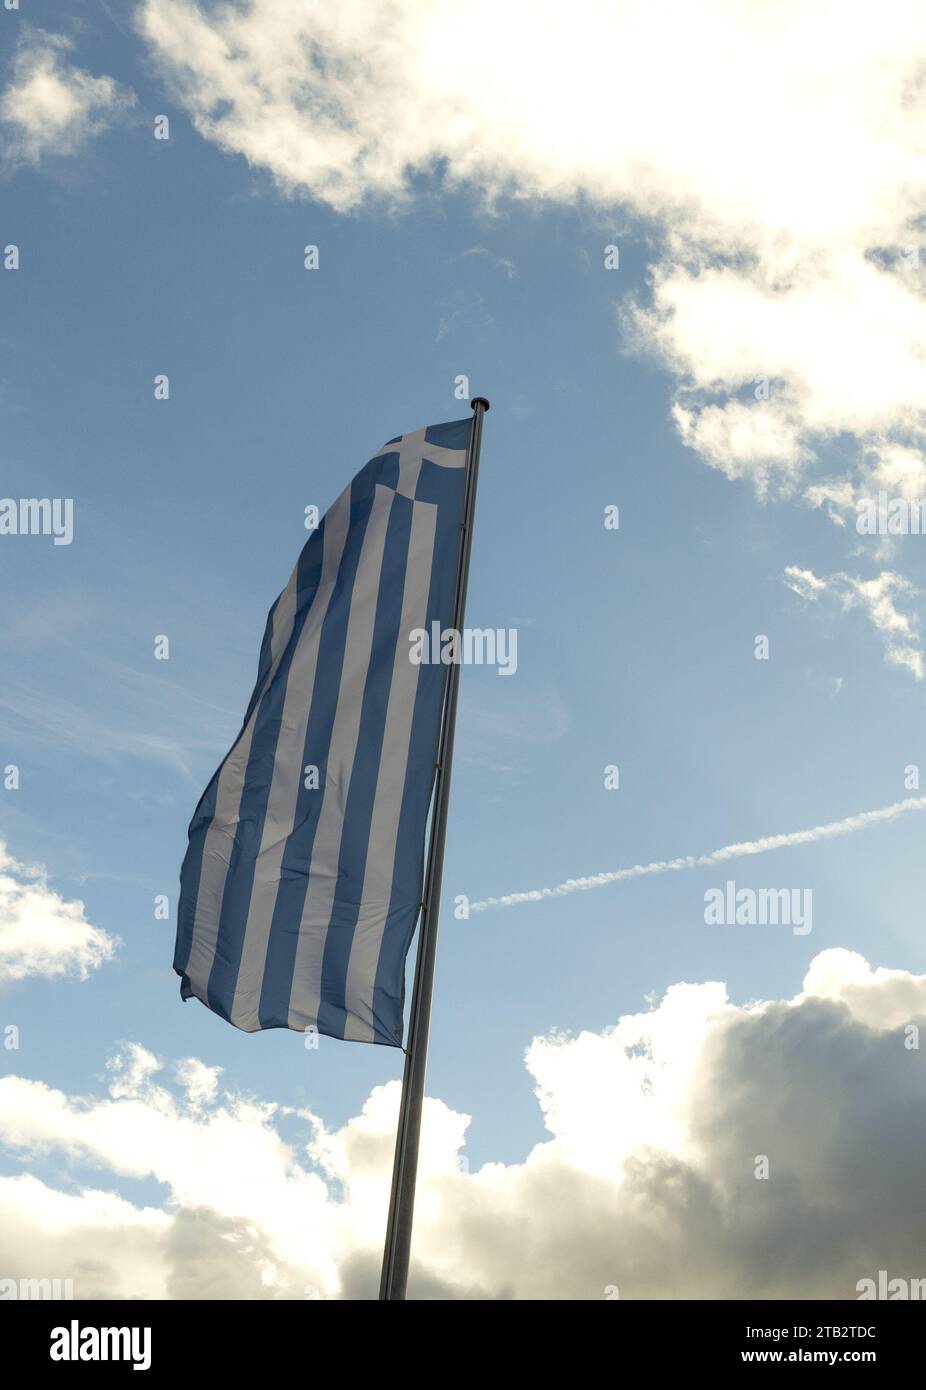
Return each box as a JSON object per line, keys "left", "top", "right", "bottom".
{"left": 0, "top": 3, "right": 926, "bottom": 1301}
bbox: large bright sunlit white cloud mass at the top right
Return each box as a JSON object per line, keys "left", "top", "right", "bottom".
{"left": 139, "top": 0, "right": 926, "bottom": 511}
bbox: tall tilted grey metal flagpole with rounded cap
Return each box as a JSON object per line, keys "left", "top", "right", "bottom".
{"left": 380, "top": 396, "right": 489, "bottom": 1301}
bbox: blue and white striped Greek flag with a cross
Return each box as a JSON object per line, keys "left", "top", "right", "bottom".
{"left": 174, "top": 420, "right": 473, "bottom": 1047}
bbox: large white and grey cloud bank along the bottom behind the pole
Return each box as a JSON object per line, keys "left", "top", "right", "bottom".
{"left": 0, "top": 949, "right": 926, "bottom": 1298}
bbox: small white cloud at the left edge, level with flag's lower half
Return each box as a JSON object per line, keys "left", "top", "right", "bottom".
{"left": 0, "top": 841, "right": 115, "bottom": 981}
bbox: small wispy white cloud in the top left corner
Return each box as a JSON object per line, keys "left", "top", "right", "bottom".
{"left": 0, "top": 31, "right": 135, "bottom": 164}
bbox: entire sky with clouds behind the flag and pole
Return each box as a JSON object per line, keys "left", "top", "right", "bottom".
{"left": 0, "top": 0, "right": 926, "bottom": 1298}
